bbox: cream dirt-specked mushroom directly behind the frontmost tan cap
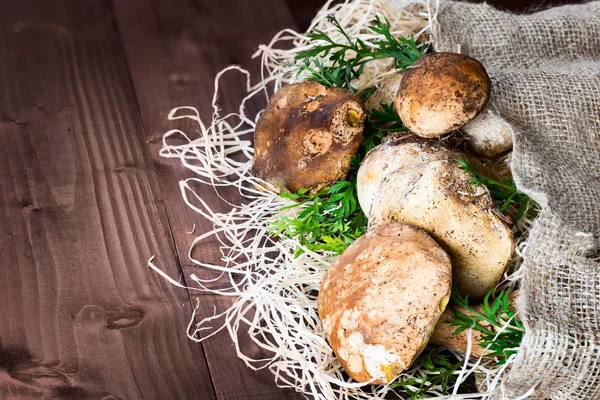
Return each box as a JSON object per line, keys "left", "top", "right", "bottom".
{"left": 369, "top": 160, "right": 514, "bottom": 298}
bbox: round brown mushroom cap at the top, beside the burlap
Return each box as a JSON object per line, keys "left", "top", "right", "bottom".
{"left": 396, "top": 53, "right": 491, "bottom": 138}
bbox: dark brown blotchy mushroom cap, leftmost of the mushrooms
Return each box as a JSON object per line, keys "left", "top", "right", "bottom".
{"left": 252, "top": 81, "right": 366, "bottom": 192}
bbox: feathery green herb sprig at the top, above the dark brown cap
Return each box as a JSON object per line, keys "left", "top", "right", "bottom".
{"left": 295, "top": 15, "right": 428, "bottom": 92}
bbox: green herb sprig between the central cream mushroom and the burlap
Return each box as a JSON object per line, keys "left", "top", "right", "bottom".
{"left": 456, "top": 158, "right": 537, "bottom": 223}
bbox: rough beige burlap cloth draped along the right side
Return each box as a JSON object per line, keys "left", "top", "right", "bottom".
{"left": 433, "top": 2, "right": 600, "bottom": 400}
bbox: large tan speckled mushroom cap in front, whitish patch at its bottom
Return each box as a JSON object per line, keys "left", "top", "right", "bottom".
{"left": 318, "top": 223, "right": 452, "bottom": 383}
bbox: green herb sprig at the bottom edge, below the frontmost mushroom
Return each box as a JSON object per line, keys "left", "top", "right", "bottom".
{"left": 390, "top": 345, "right": 464, "bottom": 399}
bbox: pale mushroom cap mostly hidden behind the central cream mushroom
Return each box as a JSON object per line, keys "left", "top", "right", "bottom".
{"left": 356, "top": 133, "right": 468, "bottom": 217}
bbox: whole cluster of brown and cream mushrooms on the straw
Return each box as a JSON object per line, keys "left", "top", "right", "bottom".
{"left": 253, "top": 53, "right": 514, "bottom": 383}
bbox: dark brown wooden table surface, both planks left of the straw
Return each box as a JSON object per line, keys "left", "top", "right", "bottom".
{"left": 0, "top": 0, "right": 580, "bottom": 400}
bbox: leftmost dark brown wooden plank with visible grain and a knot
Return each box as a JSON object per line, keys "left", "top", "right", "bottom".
{"left": 0, "top": 0, "right": 215, "bottom": 400}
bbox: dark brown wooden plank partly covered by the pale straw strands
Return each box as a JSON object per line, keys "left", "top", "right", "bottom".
{"left": 115, "top": 0, "right": 301, "bottom": 400}
